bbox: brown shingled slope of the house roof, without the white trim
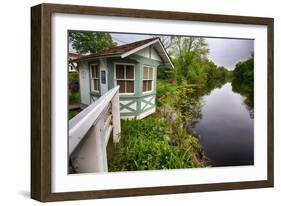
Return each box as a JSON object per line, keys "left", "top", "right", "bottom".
{"left": 70, "top": 37, "right": 159, "bottom": 61}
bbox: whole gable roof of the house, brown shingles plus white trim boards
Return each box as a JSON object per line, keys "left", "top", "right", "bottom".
{"left": 71, "top": 37, "right": 174, "bottom": 67}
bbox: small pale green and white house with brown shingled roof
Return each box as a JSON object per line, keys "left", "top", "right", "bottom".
{"left": 70, "top": 37, "right": 173, "bottom": 119}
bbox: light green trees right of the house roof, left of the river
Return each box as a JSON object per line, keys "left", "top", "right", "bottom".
{"left": 158, "top": 36, "right": 232, "bottom": 93}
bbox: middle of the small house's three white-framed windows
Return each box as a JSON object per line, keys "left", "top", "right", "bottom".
{"left": 115, "top": 64, "right": 135, "bottom": 94}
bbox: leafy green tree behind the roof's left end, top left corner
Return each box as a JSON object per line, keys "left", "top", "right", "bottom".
{"left": 69, "top": 31, "right": 117, "bottom": 54}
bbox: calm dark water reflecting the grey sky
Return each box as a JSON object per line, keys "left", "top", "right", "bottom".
{"left": 194, "top": 83, "right": 254, "bottom": 166}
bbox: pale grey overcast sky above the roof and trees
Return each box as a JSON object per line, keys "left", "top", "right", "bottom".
{"left": 70, "top": 33, "right": 254, "bottom": 70}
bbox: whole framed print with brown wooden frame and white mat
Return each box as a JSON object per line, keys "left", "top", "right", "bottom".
{"left": 31, "top": 4, "right": 274, "bottom": 202}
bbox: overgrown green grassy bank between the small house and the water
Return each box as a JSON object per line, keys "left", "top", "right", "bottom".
{"left": 108, "top": 81, "right": 206, "bottom": 171}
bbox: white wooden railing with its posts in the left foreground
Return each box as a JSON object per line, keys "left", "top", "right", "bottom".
{"left": 68, "top": 86, "right": 121, "bottom": 173}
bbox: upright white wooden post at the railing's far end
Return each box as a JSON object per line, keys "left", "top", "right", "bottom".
{"left": 111, "top": 89, "right": 121, "bottom": 143}
